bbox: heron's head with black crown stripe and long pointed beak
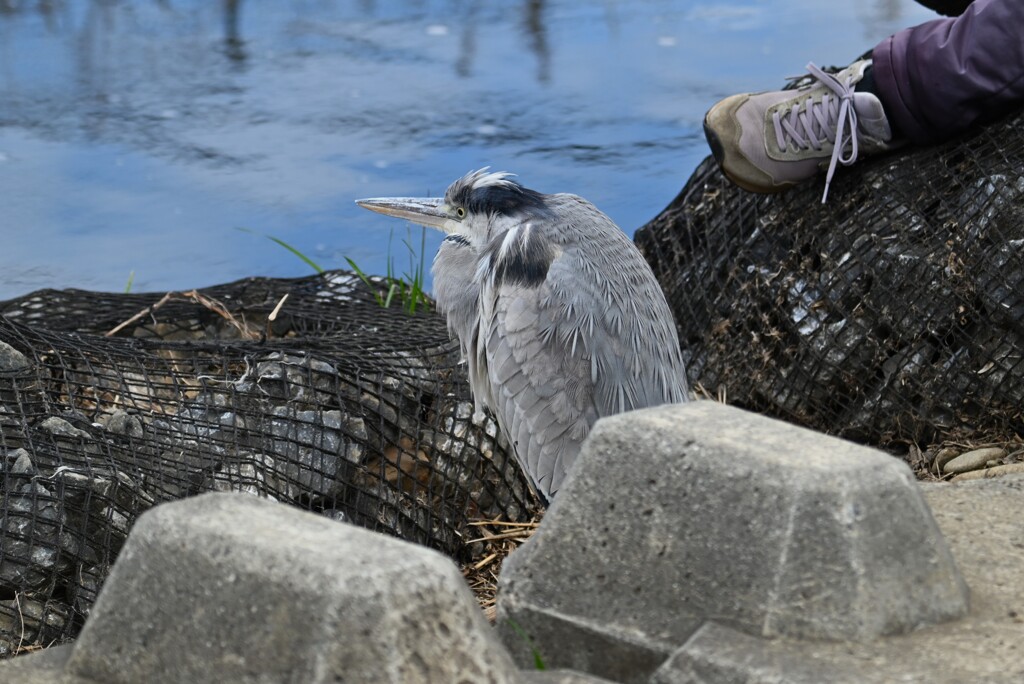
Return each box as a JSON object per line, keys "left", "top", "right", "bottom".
{"left": 355, "top": 168, "right": 550, "bottom": 246}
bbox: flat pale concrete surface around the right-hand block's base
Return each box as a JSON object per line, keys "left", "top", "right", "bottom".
{"left": 651, "top": 476, "right": 1024, "bottom": 684}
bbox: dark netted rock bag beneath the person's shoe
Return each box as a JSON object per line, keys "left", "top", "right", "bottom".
{"left": 637, "top": 105, "right": 1024, "bottom": 451}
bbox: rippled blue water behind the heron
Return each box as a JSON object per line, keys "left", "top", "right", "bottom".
{"left": 0, "top": 0, "right": 934, "bottom": 299}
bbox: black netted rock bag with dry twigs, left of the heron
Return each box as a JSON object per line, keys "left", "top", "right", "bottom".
{"left": 0, "top": 272, "right": 537, "bottom": 655}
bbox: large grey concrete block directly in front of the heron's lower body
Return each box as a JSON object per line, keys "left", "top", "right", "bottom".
{"left": 498, "top": 401, "right": 968, "bottom": 681}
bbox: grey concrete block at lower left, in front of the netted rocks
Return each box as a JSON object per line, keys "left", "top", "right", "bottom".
{"left": 61, "top": 494, "right": 519, "bottom": 684}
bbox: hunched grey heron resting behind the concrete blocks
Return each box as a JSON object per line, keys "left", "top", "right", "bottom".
{"left": 357, "top": 168, "right": 688, "bottom": 500}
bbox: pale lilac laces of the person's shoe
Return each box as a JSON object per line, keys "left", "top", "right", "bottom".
{"left": 772, "top": 63, "right": 857, "bottom": 204}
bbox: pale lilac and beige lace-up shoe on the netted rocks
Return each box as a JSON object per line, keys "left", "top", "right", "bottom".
{"left": 703, "top": 59, "right": 897, "bottom": 202}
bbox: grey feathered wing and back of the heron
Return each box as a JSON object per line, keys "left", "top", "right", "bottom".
{"left": 474, "top": 209, "right": 687, "bottom": 497}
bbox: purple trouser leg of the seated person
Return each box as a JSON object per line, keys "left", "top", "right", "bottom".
{"left": 872, "top": 0, "right": 1024, "bottom": 144}
